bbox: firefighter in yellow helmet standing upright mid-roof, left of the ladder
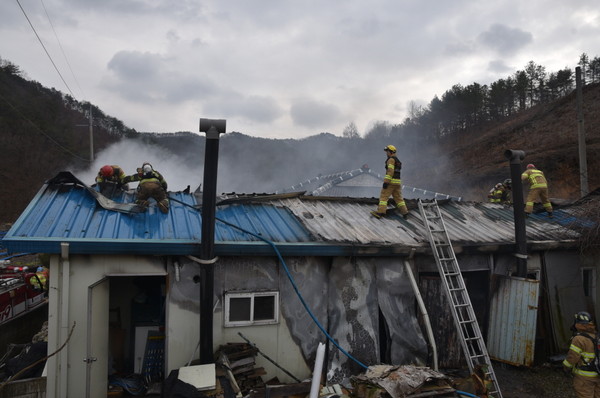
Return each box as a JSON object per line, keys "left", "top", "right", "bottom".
{"left": 371, "top": 145, "right": 408, "bottom": 219}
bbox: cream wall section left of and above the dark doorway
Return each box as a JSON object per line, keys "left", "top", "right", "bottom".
{"left": 47, "top": 255, "right": 165, "bottom": 398}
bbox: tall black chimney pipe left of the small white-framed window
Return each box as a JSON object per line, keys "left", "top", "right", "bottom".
{"left": 200, "top": 118, "right": 226, "bottom": 364}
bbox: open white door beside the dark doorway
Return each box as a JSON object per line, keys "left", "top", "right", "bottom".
{"left": 84, "top": 278, "right": 109, "bottom": 398}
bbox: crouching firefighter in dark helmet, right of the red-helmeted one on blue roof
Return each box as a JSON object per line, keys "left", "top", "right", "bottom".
{"left": 125, "top": 162, "right": 169, "bottom": 214}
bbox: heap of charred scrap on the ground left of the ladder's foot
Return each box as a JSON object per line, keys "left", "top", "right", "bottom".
{"left": 350, "top": 365, "right": 452, "bottom": 398}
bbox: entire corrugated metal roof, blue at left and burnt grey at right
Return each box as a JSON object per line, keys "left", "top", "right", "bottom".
{"left": 3, "top": 172, "right": 578, "bottom": 256}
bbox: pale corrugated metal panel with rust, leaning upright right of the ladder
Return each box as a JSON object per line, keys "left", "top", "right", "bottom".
{"left": 487, "top": 275, "right": 540, "bottom": 366}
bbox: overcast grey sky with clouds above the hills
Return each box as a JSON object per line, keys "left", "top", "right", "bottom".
{"left": 0, "top": 0, "right": 600, "bottom": 138}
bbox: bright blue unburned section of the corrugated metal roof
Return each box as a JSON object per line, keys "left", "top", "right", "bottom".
{"left": 3, "top": 173, "right": 311, "bottom": 255}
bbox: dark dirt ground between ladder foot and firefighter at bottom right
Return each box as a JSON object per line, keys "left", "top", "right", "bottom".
{"left": 493, "top": 362, "right": 576, "bottom": 398}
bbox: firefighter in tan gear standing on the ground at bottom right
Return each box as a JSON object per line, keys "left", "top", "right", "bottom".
{"left": 563, "top": 311, "right": 600, "bottom": 398}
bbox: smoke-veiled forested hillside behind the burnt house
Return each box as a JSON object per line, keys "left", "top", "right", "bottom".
{"left": 0, "top": 57, "right": 600, "bottom": 222}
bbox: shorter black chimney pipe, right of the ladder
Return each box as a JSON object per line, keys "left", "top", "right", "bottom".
{"left": 504, "top": 149, "right": 527, "bottom": 278}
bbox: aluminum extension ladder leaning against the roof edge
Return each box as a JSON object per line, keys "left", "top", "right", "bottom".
{"left": 419, "top": 199, "right": 502, "bottom": 398}
